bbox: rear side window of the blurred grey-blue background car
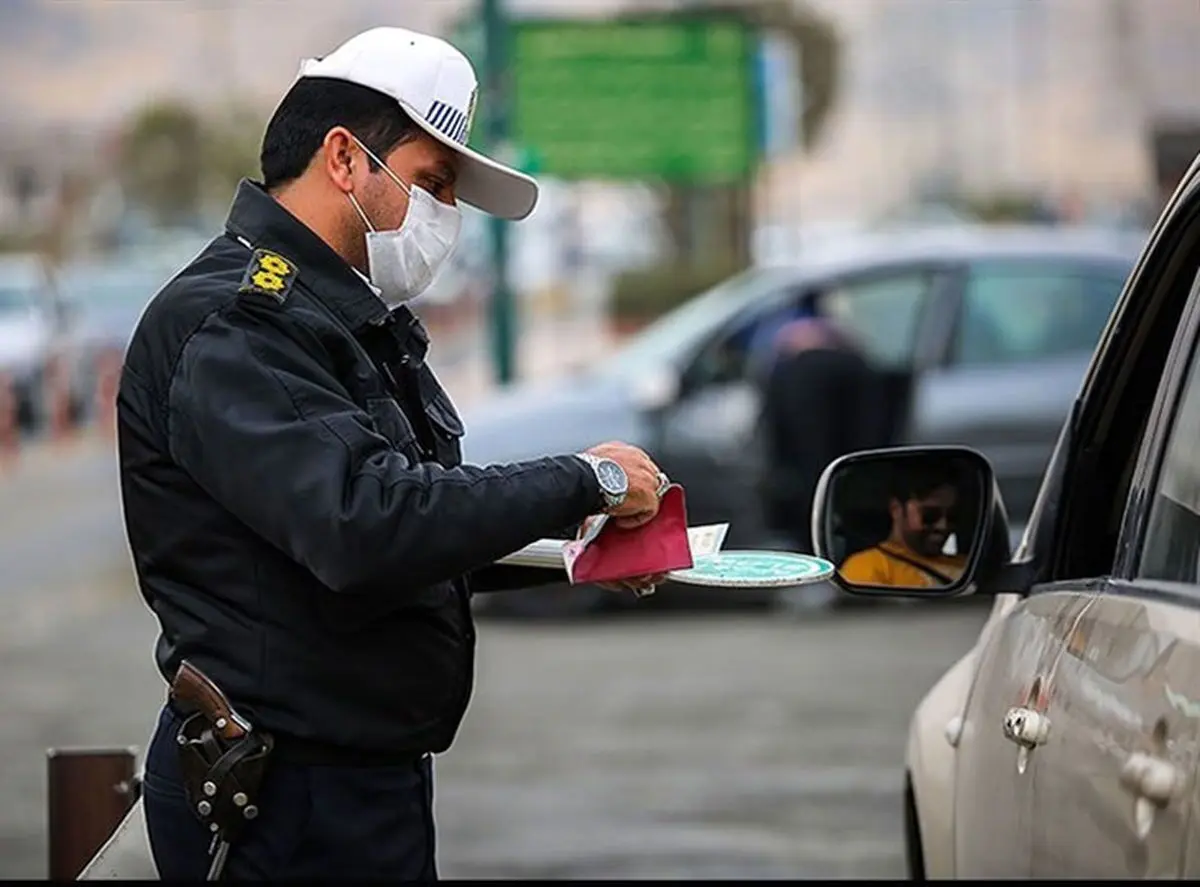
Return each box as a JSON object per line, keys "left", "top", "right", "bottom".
{"left": 952, "top": 263, "right": 1124, "bottom": 366}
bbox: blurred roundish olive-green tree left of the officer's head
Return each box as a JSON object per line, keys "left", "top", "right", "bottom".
{"left": 118, "top": 101, "right": 204, "bottom": 224}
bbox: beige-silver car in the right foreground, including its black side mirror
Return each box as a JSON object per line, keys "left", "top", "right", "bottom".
{"left": 814, "top": 158, "right": 1200, "bottom": 880}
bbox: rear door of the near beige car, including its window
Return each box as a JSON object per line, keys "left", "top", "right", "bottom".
{"left": 1031, "top": 263, "right": 1200, "bottom": 879}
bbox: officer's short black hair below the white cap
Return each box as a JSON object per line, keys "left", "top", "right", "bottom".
{"left": 259, "top": 77, "right": 420, "bottom": 191}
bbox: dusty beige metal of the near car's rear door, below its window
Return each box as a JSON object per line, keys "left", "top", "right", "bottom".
{"left": 1031, "top": 592, "right": 1200, "bottom": 879}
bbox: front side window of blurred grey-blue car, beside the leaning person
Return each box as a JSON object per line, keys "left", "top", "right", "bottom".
{"left": 821, "top": 270, "right": 934, "bottom": 368}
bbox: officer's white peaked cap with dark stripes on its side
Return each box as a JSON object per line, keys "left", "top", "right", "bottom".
{"left": 300, "top": 28, "right": 538, "bottom": 220}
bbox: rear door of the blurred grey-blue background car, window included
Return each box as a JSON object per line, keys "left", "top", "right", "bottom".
{"left": 907, "top": 259, "right": 1127, "bottom": 523}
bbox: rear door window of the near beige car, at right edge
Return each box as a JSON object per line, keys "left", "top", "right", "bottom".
{"left": 1138, "top": 319, "right": 1200, "bottom": 583}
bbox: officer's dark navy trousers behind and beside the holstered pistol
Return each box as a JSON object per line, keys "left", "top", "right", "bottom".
{"left": 143, "top": 708, "right": 438, "bottom": 881}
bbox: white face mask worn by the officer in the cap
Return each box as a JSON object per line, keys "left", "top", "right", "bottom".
{"left": 348, "top": 139, "right": 462, "bottom": 307}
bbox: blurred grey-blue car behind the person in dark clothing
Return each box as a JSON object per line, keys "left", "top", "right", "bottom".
{"left": 463, "top": 226, "right": 1142, "bottom": 616}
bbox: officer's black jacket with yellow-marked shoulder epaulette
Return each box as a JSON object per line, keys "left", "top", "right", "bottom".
{"left": 118, "top": 181, "right": 601, "bottom": 756}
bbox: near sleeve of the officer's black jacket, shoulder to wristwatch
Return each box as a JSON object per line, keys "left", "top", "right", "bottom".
{"left": 167, "top": 304, "right": 601, "bottom": 592}
